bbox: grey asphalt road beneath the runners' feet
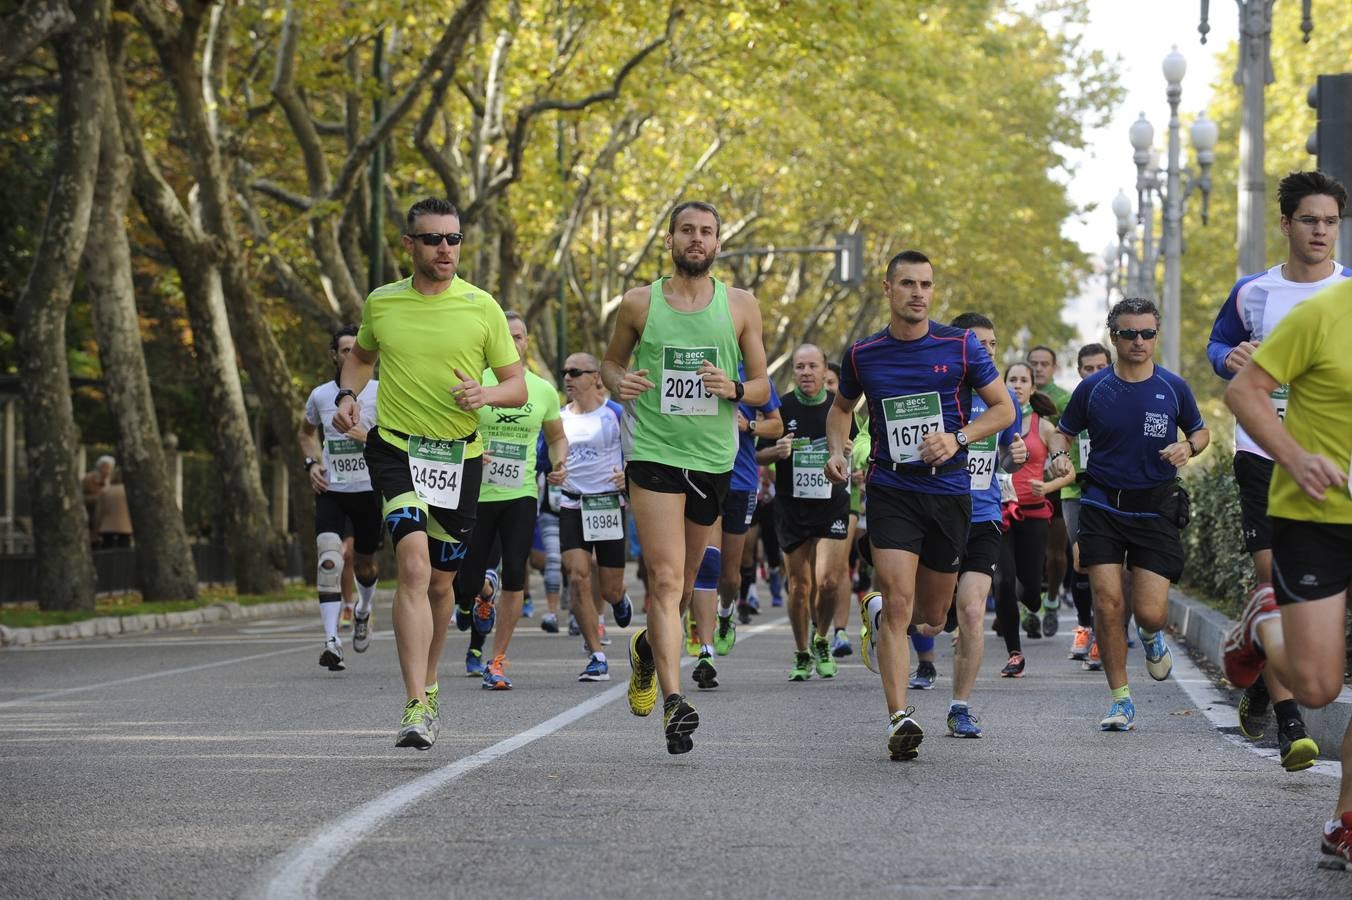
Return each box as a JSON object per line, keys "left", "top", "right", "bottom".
{"left": 0, "top": 567, "right": 1352, "bottom": 900}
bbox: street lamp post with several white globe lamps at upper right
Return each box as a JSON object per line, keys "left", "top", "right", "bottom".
{"left": 1113, "top": 47, "right": 1218, "bottom": 372}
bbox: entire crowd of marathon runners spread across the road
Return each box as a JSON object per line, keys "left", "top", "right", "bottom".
{"left": 300, "top": 172, "right": 1352, "bottom": 868}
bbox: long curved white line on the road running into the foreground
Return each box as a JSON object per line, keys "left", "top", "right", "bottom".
{"left": 254, "top": 619, "right": 787, "bottom": 900}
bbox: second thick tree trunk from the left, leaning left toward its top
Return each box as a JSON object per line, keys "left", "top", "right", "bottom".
{"left": 84, "top": 43, "right": 197, "bottom": 600}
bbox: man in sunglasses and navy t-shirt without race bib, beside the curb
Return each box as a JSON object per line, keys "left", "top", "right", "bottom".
{"left": 1048, "top": 297, "right": 1211, "bottom": 731}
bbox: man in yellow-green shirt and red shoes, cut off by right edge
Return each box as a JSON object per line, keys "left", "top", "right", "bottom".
{"left": 1225, "top": 277, "right": 1352, "bottom": 870}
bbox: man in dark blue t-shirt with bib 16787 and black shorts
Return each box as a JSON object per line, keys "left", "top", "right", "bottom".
{"left": 826, "top": 250, "right": 1014, "bottom": 759}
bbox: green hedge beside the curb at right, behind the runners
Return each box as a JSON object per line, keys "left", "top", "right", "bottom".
{"left": 1183, "top": 447, "right": 1253, "bottom": 616}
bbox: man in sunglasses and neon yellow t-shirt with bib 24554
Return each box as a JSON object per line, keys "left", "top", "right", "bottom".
{"left": 334, "top": 199, "right": 527, "bottom": 750}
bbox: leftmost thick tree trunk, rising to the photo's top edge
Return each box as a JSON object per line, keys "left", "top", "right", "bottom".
{"left": 16, "top": 0, "right": 108, "bottom": 609}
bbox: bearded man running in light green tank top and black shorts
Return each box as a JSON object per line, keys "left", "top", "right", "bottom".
{"left": 602, "top": 201, "right": 769, "bottom": 753}
